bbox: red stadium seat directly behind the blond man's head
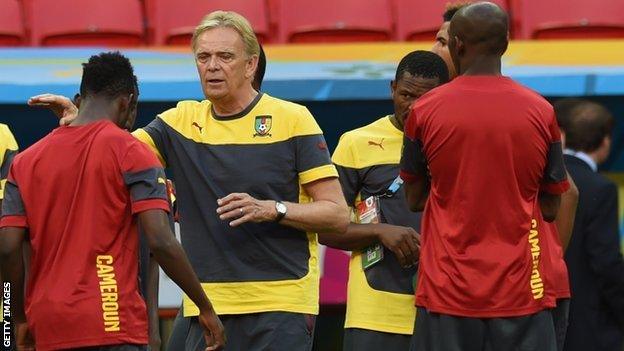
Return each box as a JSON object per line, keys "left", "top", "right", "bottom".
{"left": 146, "top": 0, "right": 271, "bottom": 45}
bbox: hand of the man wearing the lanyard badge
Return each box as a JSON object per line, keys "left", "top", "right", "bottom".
{"left": 376, "top": 223, "right": 420, "bottom": 268}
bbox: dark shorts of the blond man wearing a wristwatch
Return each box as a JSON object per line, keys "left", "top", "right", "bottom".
{"left": 167, "top": 312, "right": 316, "bottom": 351}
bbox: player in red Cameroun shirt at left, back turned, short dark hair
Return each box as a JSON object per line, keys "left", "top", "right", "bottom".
{"left": 0, "top": 53, "right": 224, "bottom": 351}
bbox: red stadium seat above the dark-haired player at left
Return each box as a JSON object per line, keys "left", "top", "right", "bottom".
{"left": 25, "top": 0, "right": 144, "bottom": 46}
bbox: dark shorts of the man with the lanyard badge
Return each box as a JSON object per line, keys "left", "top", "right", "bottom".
{"left": 342, "top": 328, "right": 412, "bottom": 351}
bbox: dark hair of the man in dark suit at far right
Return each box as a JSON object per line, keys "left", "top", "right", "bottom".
{"left": 555, "top": 98, "right": 615, "bottom": 152}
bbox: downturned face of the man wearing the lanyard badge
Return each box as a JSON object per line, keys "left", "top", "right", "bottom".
{"left": 390, "top": 72, "right": 440, "bottom": 126}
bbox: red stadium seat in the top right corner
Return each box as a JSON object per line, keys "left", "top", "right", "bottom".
{"left": 512, "top": 0, "right": 624, "bottom": 39}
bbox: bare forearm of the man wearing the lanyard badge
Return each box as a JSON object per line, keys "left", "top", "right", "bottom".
{"left": 319, "top": 223, "right": 379, "bottom": 251}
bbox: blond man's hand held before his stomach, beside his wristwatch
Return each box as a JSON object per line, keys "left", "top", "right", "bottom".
{"left": 217, "top": 193, "right": 277, "bottom": 227}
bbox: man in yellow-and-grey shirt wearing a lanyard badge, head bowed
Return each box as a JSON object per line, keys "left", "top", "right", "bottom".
{"left": 319, "top": 51, "right": 449, "bottom": 351}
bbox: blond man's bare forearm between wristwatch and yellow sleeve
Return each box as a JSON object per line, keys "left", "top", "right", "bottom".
{"left": 280, "top": 200, "right": 349, "bottom": 234}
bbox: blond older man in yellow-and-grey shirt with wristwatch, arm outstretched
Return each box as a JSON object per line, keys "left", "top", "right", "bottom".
{"left": 30, "top": 11, "right": 349, "bottom": 351}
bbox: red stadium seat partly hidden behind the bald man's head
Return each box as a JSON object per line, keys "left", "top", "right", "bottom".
{"left": 393, "top": 0, "right": 510, "bottom": 41}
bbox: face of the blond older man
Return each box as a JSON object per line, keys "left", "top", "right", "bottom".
{"left": 195, "top": 27, "right": 258, "bottom": 102}
